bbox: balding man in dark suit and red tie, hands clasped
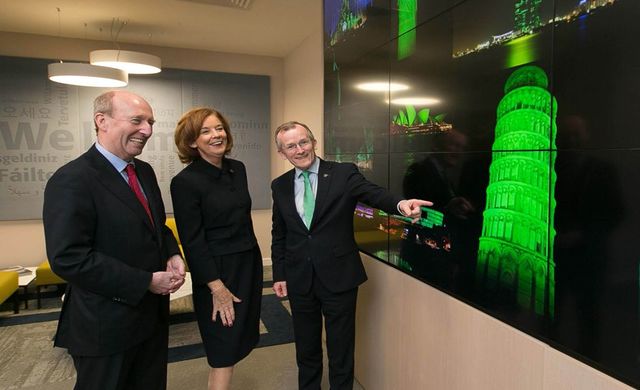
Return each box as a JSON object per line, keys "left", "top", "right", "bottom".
{"left": 43, "top": 91, "right": 185, "bottom": 390}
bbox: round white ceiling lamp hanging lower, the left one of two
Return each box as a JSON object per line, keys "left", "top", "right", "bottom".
{"left": 48, "top": 62, "right": 129, "bottom": 88}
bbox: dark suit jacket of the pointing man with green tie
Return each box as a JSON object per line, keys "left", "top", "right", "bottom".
{"left": 271, "top": 159, "right": 401, "bottom": 293}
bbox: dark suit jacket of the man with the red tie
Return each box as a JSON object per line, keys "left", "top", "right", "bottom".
{"left": 43, "top": 145, "right": 179, "bottom": 356}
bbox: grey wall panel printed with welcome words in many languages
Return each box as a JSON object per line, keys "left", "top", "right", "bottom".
{"left": 0, "top": 57, "right": 271, "bottom": 220}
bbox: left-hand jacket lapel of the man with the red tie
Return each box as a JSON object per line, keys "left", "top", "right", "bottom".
{"left": 89, "top": 146, "right": 155, "bottom": 232}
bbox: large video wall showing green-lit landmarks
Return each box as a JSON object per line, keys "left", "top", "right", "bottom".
{"left": 324, "top": 0, "right": 640, "bottom": 387}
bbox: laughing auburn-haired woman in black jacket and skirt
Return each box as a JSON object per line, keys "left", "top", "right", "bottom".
{"left": 171, "top": 108, "right": 262, "bottom": 390}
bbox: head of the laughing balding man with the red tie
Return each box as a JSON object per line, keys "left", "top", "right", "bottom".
{"left": 95, "top": 91, "right": 155, "bottom": 161}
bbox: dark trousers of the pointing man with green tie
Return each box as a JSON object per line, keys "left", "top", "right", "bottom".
{"left": 289, "top": 277, "right": 358, "bottom": 390}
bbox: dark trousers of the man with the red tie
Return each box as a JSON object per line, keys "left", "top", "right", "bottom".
{"left": 72, "top": 324, "right": 168, "bottom": 390}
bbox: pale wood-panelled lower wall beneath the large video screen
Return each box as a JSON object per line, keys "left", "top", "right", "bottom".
{"left": 355, "top": 255, "right": 630, "bottom": 390}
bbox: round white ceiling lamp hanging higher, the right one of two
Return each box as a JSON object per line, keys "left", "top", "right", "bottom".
{"left": 89, "top": 50, "right": 161, "bottom": 74}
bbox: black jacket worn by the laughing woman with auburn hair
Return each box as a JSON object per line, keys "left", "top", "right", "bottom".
{"left": 171, "top": 158, "right": 258, "bottom": 284}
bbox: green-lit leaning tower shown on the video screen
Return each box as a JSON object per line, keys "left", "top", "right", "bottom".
{"left": 476, "top": 66, "right": 557, "bottom": 317}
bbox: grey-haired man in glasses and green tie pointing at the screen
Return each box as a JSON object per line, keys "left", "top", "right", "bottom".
{"left": 271, "top": 122, "right": 431, "bottom": 390}
